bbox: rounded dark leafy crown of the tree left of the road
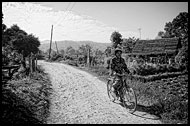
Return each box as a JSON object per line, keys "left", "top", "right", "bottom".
{"left": 3, "top": 24, "right": 40, "bottom": 65}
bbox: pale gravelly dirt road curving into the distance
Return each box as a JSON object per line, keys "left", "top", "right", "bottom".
{"left": 39, "top": 61, "right": 161, "bottom": 124}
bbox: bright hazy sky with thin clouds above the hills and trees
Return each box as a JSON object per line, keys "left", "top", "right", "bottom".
{"left": 3, "top": 2, "right": 188, "bottom": 42}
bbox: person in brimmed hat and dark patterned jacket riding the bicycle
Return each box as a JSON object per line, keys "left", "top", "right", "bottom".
{"left": 109, "top": 47, "right": 130, "bottom": 99}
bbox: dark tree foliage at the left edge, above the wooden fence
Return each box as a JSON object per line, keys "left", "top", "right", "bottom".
{"left": 2, "top": 13, "right": 40, "bottom": 65}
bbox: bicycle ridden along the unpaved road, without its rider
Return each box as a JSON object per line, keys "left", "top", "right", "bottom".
{"left": 107, "top": 73, "right": 137, "bottom": 113}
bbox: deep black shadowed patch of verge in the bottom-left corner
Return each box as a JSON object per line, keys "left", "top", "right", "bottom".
{"left": 1, "top": 88, "right": 43, "bottom": 125}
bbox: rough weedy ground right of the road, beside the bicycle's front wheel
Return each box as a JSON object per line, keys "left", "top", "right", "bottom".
{"left": 131, "top": 74, "right": 188, "bottom": 124}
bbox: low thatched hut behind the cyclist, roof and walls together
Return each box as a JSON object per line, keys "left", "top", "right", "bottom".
{"left": 126, "top": 38, "right": 182, "bottom": 64}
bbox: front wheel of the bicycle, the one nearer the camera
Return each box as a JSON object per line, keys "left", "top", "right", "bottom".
{"left": 123, "top": 87, "right": 137, "bottom": 113}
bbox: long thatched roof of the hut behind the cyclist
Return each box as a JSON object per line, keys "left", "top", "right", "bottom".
{"left": 132, "top": 38, "right": 181, "bottom": 55}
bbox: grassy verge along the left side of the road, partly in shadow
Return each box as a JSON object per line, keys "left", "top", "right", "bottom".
{"left": 2, "top": 67, "right": 51, "bottom": 124}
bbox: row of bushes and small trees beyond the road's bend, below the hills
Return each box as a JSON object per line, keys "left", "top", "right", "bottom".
{"left": 46, "top": 44, "right": 104, "bottom": 66}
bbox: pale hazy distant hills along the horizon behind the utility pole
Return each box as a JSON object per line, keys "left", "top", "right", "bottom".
{"left": 39, "top": 40, "right": 111, "bottom": 51}
